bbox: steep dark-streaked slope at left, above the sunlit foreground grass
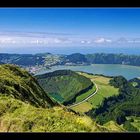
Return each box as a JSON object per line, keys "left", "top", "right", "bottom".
{"left": 0, "top": 64, "right": 54, "bottom": 107}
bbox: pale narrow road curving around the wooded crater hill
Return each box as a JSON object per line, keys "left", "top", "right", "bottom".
{"left": 67, "top": 82, "right": 98, "bottom": 108}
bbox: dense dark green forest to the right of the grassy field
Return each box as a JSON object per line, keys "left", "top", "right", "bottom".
{"left": 87, "top": 76, "right": 140, "bottom": 131}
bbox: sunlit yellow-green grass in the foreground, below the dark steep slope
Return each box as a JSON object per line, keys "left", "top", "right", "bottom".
{"left": 0, "top": 95, "right": 112, "bottom": 132}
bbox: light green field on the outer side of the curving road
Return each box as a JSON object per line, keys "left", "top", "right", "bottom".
{"left": 72, "top": 72, "right": 119, "bottom": 113}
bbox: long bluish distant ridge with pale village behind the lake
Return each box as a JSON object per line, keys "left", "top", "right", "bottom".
{"left": 0, "top": 53, "right": 140, "bottom": 67}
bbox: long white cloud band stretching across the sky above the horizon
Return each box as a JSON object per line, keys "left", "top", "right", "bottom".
{"left": 0, "top": 32, "right": 140, "bottom": 47}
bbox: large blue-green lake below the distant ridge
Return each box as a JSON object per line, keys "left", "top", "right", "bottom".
{"left": 38, "top": 64, "right": 140, "bottom": 80}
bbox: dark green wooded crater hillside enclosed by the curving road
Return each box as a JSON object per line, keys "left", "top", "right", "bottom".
{"left": 36, "top": 70, "right": 93, "bottom": 104}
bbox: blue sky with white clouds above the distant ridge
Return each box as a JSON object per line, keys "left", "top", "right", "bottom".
{"left": 0, "top": 8, "right": 140, "bottom": 53}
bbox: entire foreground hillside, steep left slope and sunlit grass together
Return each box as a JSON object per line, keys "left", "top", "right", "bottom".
{"left": 0, "top": 65, "right": 124, "bottom": 132}
